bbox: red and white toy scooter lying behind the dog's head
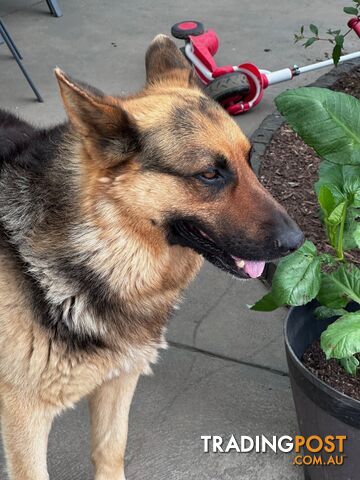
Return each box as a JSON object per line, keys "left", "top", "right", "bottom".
{"left": 171, "top": 18, "right": 360, "bottom": 115}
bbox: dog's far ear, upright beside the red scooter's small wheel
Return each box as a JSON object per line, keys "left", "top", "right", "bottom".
{"left": 145, "top": 34, "right": 198, "bottom": 88}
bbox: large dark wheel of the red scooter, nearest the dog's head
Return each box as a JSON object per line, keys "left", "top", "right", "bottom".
{"left": 204, "top": 72, "right": 250, "bottom": 106}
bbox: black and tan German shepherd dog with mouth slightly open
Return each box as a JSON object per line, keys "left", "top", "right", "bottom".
{"left": 0, "top": 35, "right": 303, "bottom": 480}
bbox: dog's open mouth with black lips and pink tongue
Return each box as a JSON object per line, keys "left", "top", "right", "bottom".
{"left": 170, "top": 220, "right": 265, "bottom": 278}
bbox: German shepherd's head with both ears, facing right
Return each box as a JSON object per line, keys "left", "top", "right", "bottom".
{"left": 56, "top": 35, "right": 303, "bottom": 278}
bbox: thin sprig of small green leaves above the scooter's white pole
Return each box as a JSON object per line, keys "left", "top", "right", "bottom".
{"left": 294, "top": 0, "right": 360, "bottom": 65}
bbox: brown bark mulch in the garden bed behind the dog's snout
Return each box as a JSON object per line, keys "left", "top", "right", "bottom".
{"left": 260, "top": 67, "right": 360, "bottom": 264}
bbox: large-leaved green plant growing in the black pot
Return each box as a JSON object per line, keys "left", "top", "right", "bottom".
{"left": 251, "top": 88, "right": 360, "bottom": 374}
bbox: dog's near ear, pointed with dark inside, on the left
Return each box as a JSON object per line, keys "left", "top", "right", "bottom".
{"left": 55, "top": 68, "right": 139, "bottom": 166}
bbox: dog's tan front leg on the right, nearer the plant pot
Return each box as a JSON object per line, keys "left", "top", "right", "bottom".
{"left": 89, "top": 373, "right": 139, "bottom": 480}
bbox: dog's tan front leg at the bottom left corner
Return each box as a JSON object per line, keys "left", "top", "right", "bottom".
{"left": 1, "top": 393, "right": 55, "bottom": 480}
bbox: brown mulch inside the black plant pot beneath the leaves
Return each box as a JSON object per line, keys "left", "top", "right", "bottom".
{"left": 302, "top": 341, "right": 360, "bottom": 401}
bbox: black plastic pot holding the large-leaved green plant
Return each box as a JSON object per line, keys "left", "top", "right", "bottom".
{"left": 285, "top": 302, "right": 360, "bottom": 480}
